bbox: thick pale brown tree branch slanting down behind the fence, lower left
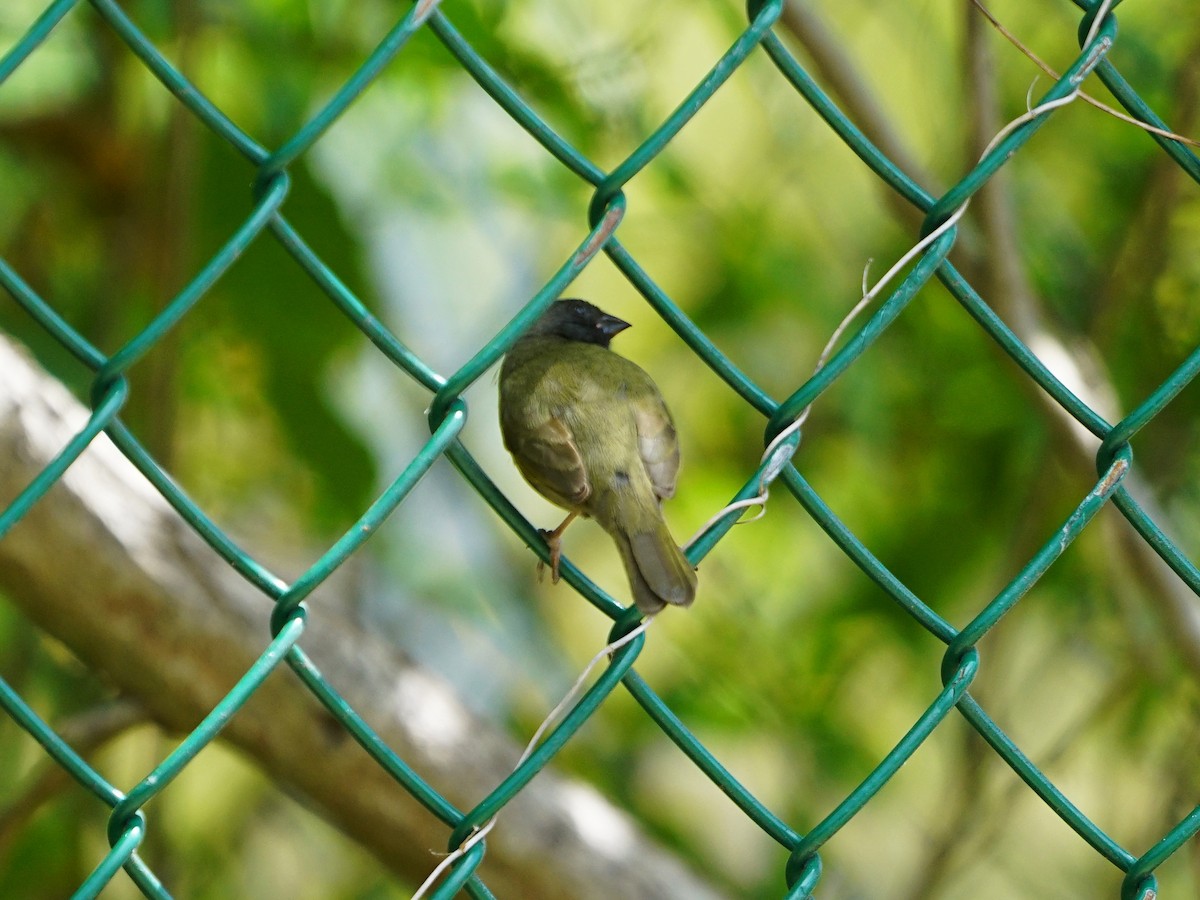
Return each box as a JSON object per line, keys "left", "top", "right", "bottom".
{"left": 0, "top": 335, "right": 718, "bottom": 899}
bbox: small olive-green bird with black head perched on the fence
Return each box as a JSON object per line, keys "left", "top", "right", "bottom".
{"left": 500, "top": 300, "right": 696, "bottom": 614}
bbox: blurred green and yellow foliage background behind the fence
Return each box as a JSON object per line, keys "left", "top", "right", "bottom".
{"left": 0, "top": 0, "right": 1200, "bottom": 900}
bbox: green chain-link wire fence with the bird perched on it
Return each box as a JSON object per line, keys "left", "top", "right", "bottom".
{"left": 0, "top": 0, "right": 1200, "bottom": 898}
